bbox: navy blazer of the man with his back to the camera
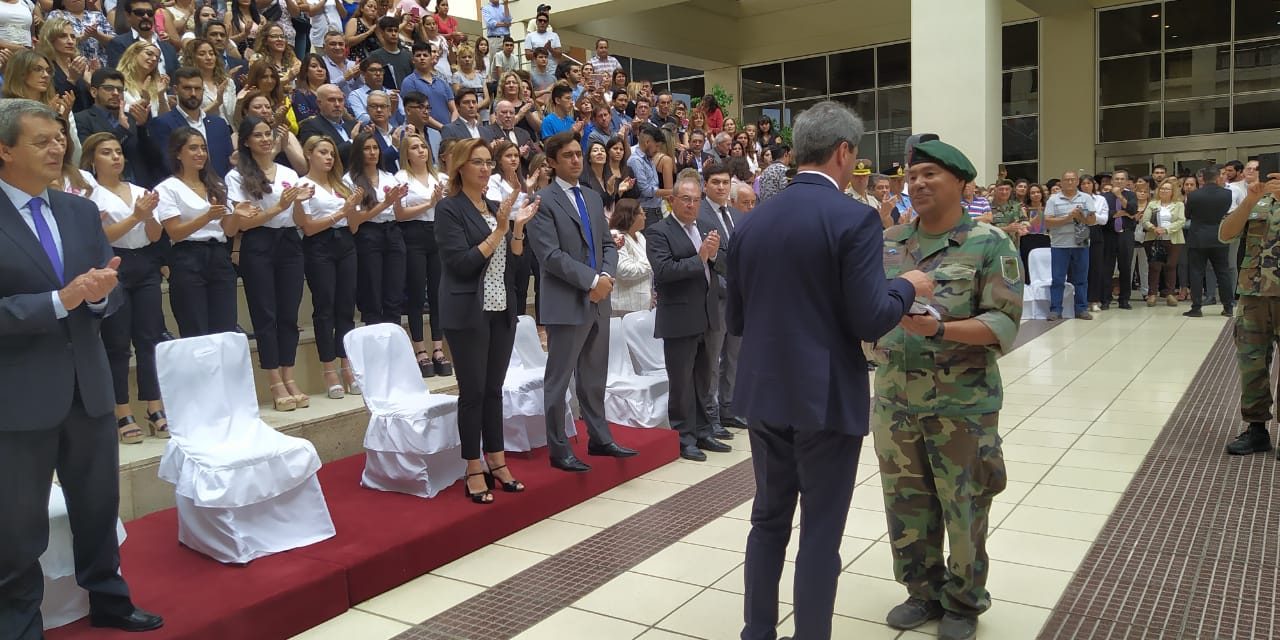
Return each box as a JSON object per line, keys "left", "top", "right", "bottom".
{"left": 726, "top": 173, "right": 915, "bottom": 435}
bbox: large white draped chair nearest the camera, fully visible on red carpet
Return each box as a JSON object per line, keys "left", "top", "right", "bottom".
{"left": 156, "top": 333, "right": 334, "bottom": 563}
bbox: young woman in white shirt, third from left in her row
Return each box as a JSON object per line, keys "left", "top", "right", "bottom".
{"left": 227, "top": 115, "right": 312, "bottom": 411}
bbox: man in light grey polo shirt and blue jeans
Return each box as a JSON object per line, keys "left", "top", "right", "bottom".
{"left": 1044, "top": 172, "right": 1097, "bottom": 321}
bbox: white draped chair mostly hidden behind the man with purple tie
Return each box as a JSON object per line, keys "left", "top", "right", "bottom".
{"left": 40, "top": 484, "right": 125, "bottom": 630}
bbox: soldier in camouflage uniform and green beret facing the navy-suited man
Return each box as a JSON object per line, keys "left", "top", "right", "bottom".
{"left": 872, "top": 141, "right": 1023, "bottom": 640}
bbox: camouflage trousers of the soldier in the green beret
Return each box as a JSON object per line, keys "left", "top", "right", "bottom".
{"left": 872, "top": 402, "right": 1006, "bottom": 616}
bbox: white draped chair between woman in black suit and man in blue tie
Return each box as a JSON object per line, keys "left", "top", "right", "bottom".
{"left": 502, "top": 316, "right": 577, "bottom": 452}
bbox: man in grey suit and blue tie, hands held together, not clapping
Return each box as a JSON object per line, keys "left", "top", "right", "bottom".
{"left": 529, "top": 131, "right": 636, "bottom": 471}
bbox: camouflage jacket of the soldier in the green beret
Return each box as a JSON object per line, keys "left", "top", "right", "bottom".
{"left": 873, "top": 215, "right": 1023, "bottom": 416}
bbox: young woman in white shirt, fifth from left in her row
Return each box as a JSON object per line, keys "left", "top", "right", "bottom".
{"left": 344, "top": 131, "right": 408, "bottom": 325}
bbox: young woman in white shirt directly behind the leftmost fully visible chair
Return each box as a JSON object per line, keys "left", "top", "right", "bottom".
{"left": 155, "top": 127, "right": 238, "bottom": 338}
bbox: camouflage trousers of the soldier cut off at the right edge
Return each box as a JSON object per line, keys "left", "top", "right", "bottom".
{"left": 1235, "top": 296, "right": 1280, "bottom": 422}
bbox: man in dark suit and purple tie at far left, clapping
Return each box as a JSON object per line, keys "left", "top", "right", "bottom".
{"left": 0, "top": 100, "right": 164, "bottom": 640}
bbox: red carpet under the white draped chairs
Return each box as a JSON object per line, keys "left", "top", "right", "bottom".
{"left": 46, "top": 425, "right": 678, "bottom": 640}
